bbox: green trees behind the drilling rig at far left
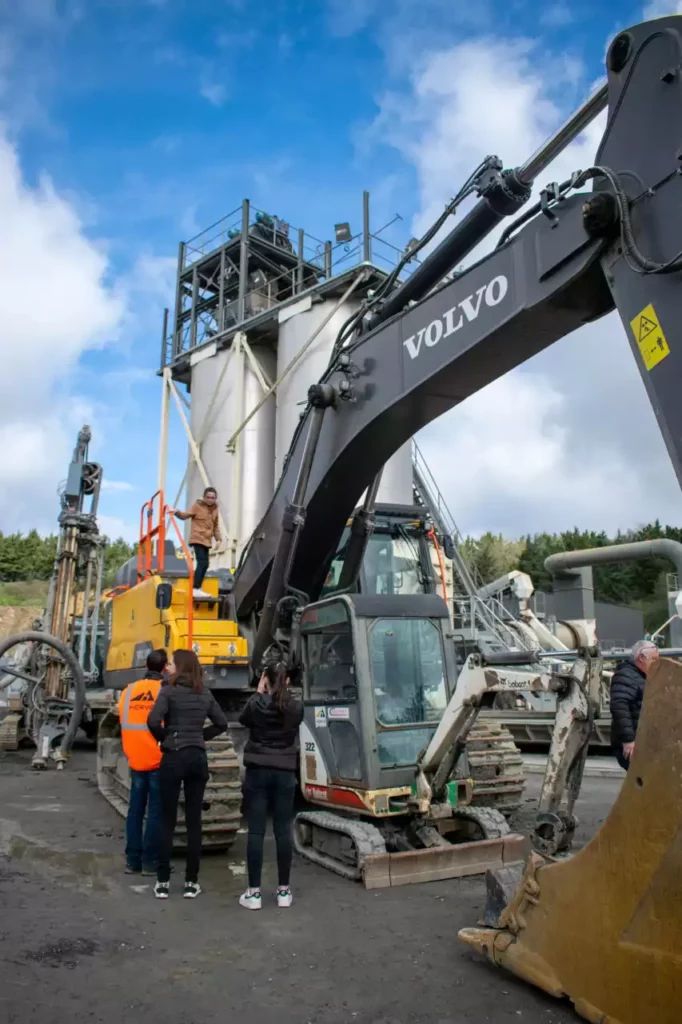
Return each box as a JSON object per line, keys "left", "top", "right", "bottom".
{"left": 0, "top": 529, "right": 137, "bottom": 587}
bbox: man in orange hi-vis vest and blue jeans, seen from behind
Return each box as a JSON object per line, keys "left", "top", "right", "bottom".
{"left": 119, "top": 650, "right": 168, "bottom": 874}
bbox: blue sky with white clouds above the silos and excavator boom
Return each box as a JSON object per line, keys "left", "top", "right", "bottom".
{"left": 0, "top": 0, "right": 682, "bottom": 537}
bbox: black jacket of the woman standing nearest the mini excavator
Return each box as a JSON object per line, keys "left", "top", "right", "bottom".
{"left": 240, "top": 693, "right": 303, "bottom": 771}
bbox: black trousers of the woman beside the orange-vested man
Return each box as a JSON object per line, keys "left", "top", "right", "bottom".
{"left": 157, "top": 746, "right": 209, "bottom": 882}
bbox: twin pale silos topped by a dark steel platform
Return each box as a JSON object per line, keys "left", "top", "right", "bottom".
{"left": 162, "top": 196, "right": 412, "bottom": 567}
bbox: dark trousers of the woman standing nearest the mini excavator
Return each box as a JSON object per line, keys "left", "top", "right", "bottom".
{"left": 244, "top": 765, "right": 296, "bottom": 889}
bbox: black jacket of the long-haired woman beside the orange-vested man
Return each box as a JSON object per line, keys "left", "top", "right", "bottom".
{"left": 146, "top": 678, "right": 227, "bottom": 754}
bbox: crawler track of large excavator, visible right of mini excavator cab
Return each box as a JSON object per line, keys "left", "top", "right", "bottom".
{"left": 466, "top": 719, "right": 525, "bottom": 814}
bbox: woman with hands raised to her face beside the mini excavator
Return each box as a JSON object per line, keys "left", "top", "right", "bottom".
{"left": 240, "top": 663, "right": 303, "bottom": 910}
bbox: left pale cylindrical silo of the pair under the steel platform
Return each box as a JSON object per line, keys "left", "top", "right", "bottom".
{"left": 186, "top": 343, "right": 276, "bottom": 568}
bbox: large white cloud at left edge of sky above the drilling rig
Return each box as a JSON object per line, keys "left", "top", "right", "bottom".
{"left": 0, "top": 133, "right": 125, "bottom": 530}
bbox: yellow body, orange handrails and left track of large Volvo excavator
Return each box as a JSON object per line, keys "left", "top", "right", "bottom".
{"left": 97, "top": 494, "right": 244, "bottom": 850}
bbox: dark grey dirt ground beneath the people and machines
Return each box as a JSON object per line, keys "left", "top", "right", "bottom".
{"left": 0, "top": 751, "right": 621, "bottom": 1024}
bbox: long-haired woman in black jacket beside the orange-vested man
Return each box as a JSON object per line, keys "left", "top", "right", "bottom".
{"left": 146, "top": 650, "right": 227, "bottom": 899}
